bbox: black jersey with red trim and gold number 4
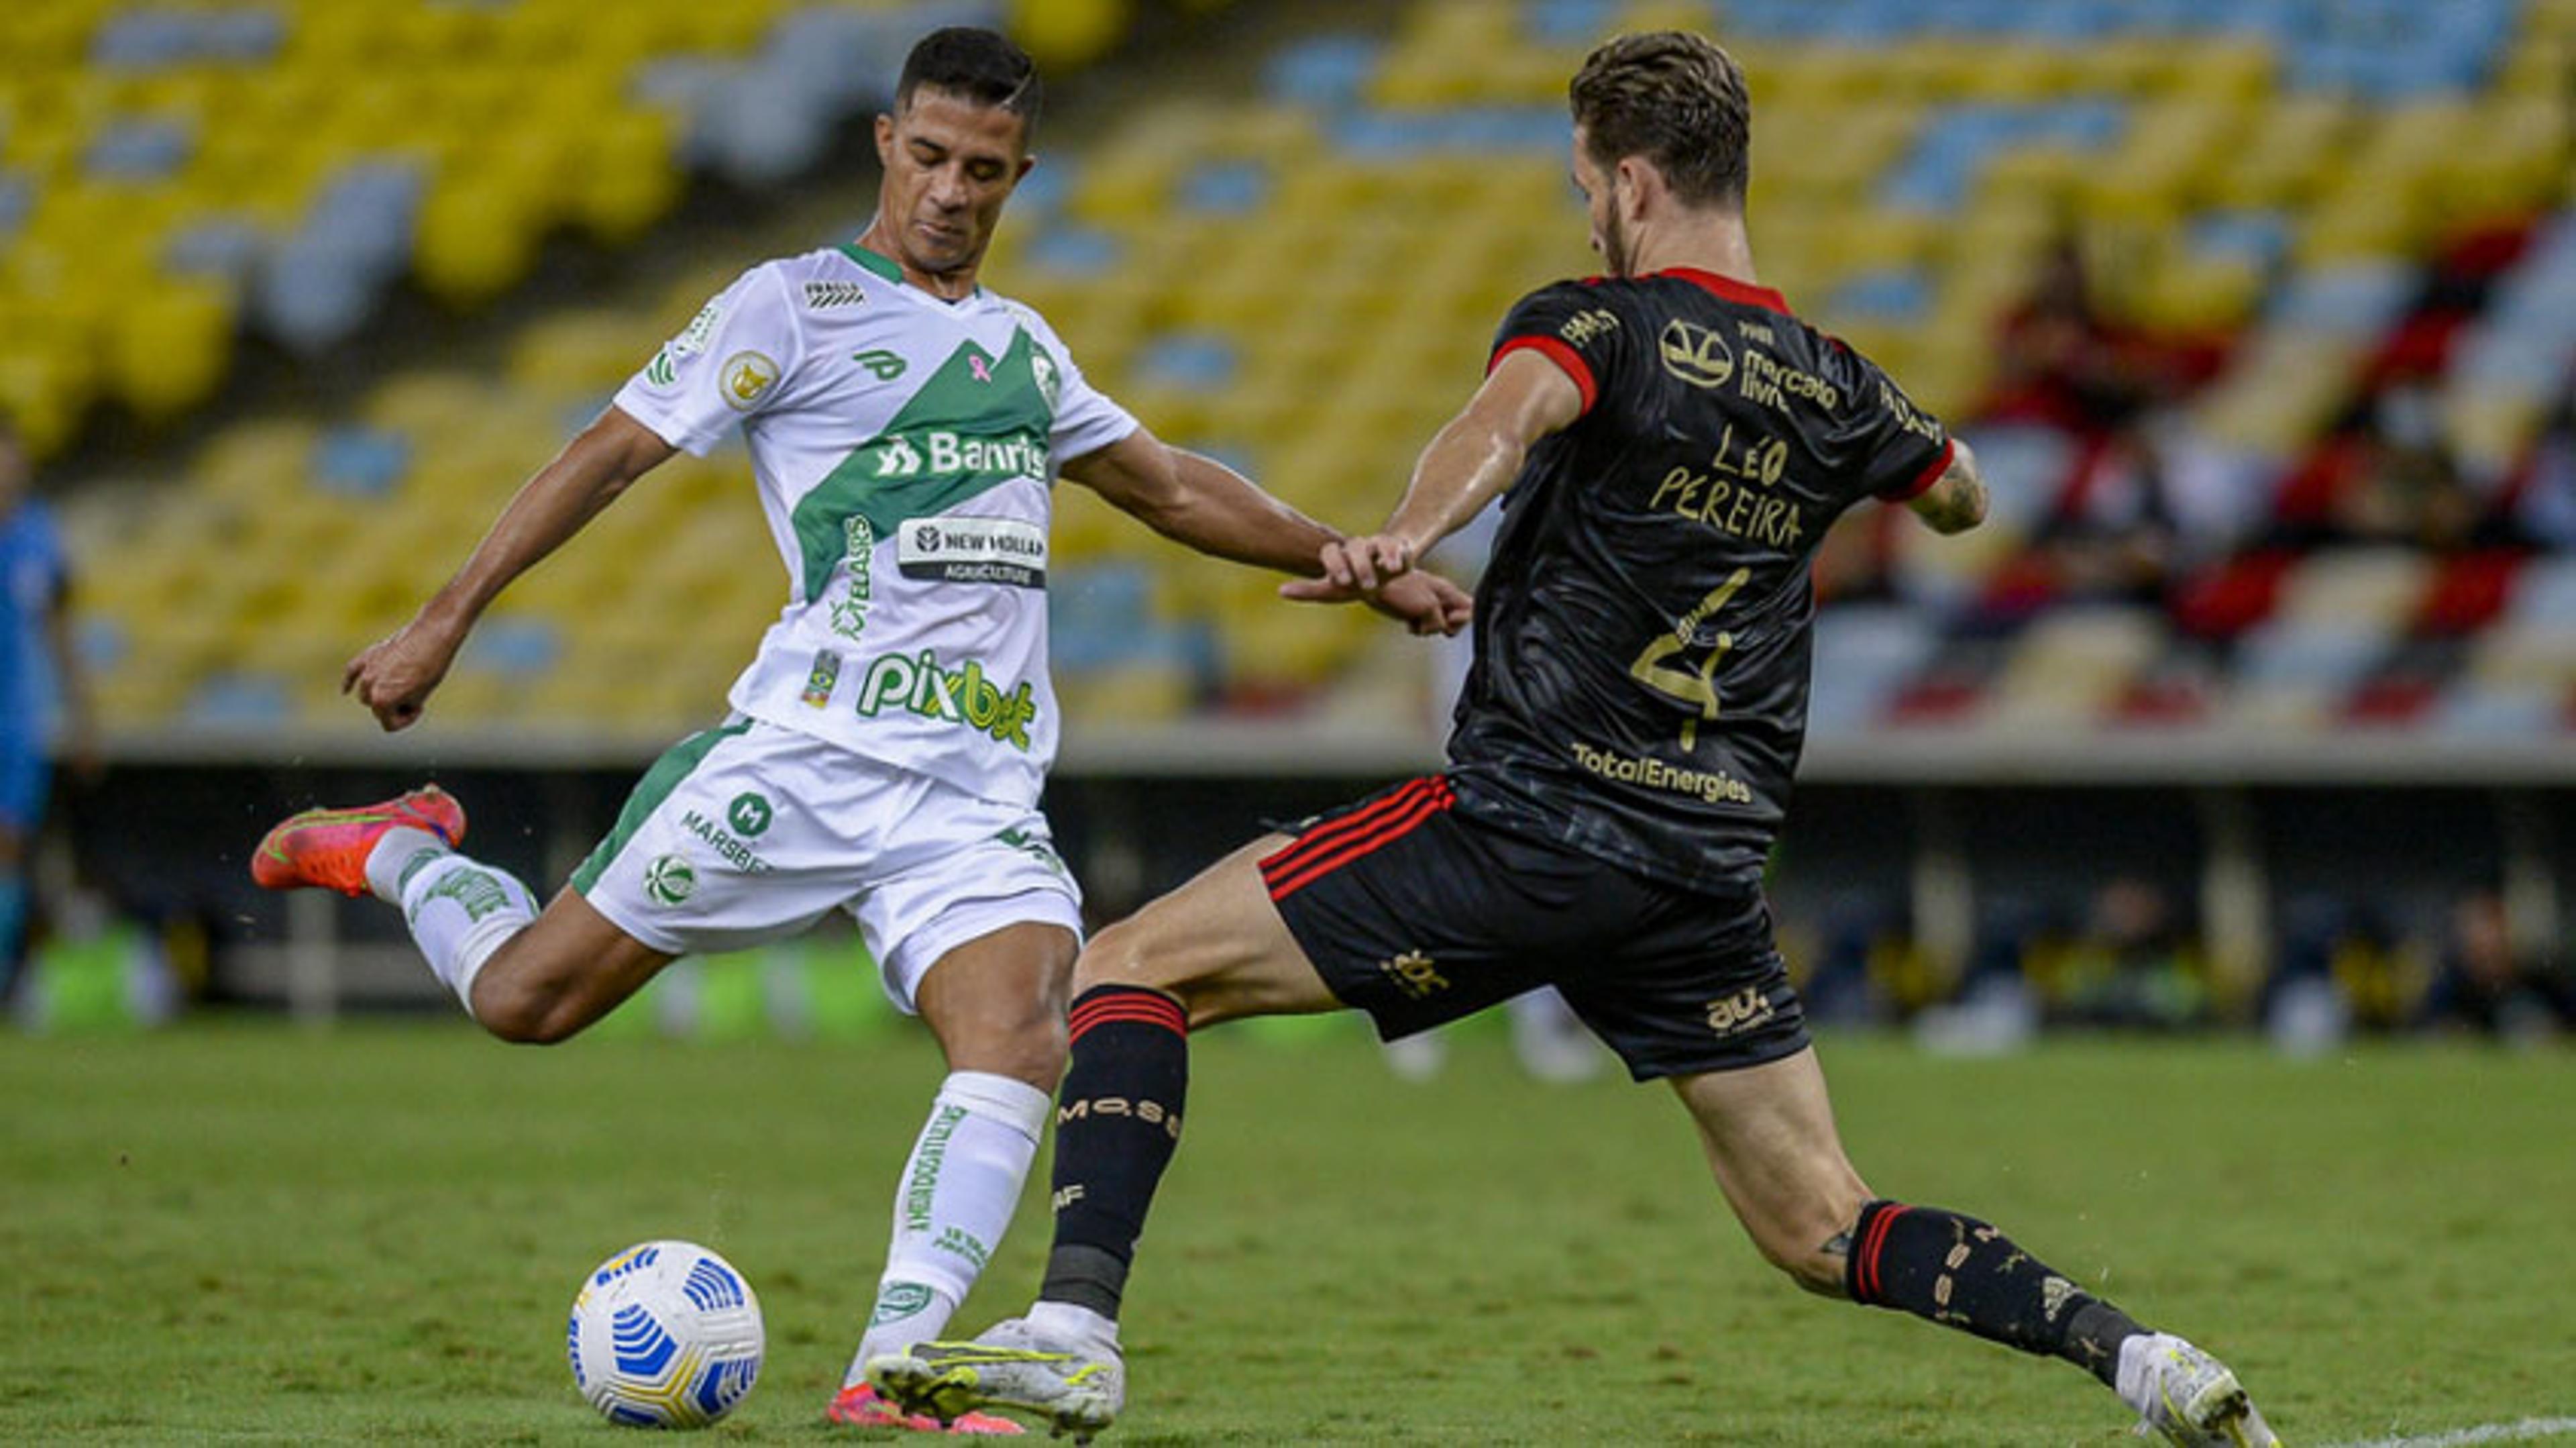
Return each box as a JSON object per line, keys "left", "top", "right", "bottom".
{"left": 1448, "top": 270, "right": 1950, "bottom": 889}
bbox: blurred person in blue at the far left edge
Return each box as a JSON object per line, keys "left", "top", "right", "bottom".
{"left": 0, "top": 415, "right": 98, "bottom": 997}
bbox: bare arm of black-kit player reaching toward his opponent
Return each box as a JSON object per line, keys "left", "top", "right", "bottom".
{"left": 1280, "top": 342, "right": 1585, "bottom": 592}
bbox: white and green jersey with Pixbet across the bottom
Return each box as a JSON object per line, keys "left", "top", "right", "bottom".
{"left": 616, "top": 248, "right": 1136, "bottom": 804}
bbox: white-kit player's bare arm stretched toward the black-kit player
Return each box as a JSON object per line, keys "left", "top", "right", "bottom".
{"left": 1064, "top": 427, "right": 1471, "bottom": 634}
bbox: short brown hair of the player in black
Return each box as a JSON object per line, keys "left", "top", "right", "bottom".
{"left": 1566, "top": 31, "right": 1754, "bottom": 206}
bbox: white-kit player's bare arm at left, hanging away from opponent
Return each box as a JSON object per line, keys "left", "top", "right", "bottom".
{"left": 340, "top": 407, "right": 672, "bottom": 732}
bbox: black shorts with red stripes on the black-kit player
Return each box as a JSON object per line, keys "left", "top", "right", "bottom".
{"left": 1260, "top": 776, "right": 1809, "bottom": 1080}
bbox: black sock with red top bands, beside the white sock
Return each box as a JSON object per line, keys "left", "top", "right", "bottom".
{"left": 1038, "top": 984, "right": 1190, "bottom": 1319}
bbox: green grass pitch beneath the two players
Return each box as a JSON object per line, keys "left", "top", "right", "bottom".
{"left": 0, "top": 1023, "right": 2576, "bottom": 1445}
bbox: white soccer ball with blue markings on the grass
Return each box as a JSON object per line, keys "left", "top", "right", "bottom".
{"left": 570, "top": 1242, "right": 765, "bottom": 1427}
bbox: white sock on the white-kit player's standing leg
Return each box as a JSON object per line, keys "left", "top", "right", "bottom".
{"left": 843, "top": 1072, "right": 1051, "bottom": 1386}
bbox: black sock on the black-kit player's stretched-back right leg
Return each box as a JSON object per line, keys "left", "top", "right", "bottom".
{"left": 1842, "top": 1200, "right": 2146, "bottom": 1386}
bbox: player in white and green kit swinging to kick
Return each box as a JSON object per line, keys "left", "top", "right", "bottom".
{"left": 252, "top": 28, "right": 1468, "bottom": 1433}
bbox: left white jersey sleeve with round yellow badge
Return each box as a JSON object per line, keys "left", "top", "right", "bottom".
{"left": 616, "top": 266, "right": 804, "bottom": 458}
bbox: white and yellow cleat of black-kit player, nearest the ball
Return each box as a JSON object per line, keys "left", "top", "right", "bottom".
{"left": 868, "top": 1316, "right": 1126, "bottom": 1443}
